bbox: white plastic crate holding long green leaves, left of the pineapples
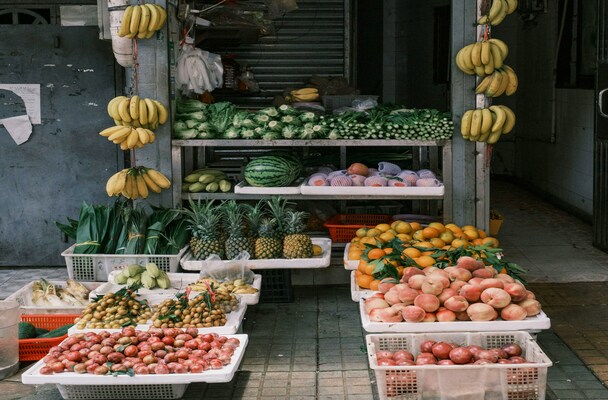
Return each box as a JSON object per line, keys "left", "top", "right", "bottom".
{"left": 61, "top": 245, "right": 188, "bottom": 282}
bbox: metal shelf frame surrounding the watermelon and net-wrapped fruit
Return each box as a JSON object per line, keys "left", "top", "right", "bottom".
{"left": 172, "top": 139, "right": 452, "bottom": 221}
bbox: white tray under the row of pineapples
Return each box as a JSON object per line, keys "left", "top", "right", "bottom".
{"left": 181, "top": 238, "right": 331, "bottom": 271}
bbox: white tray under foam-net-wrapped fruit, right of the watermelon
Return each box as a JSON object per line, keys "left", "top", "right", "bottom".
{"left": 300, "top": 182, "right": 445, "bottom": 197}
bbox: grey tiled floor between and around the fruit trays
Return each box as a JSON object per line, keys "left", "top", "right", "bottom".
{"left": 0, "top": 182, "right": 608, "bottom": 400}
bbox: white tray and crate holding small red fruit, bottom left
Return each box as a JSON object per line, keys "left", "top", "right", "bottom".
{"left": 21, "top": 330, "right": 248, "bottom": 400}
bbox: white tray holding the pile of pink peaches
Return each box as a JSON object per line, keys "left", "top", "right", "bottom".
{"left": 359, "top": 299, "right": 551, "bottom": 333}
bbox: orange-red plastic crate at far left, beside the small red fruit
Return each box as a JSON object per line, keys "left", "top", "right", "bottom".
{"left": 19, "top": 314, "right": 79, "bottom": 361}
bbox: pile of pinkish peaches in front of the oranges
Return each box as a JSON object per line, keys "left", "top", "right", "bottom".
{"left": 364, "top": 256, "right": 541, "bottom": 323}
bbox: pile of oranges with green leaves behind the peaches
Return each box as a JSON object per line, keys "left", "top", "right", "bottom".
{"left": 348, "top": 220, "right": 499, "bottom": 290}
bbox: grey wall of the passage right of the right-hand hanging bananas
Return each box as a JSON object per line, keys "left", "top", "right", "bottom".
{"left": 492, "top": 0, "right": 594, "bottom": 219}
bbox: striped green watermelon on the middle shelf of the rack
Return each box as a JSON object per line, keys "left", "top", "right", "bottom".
{"left": 244, "top": 155, "right": 302, "bottom": 187}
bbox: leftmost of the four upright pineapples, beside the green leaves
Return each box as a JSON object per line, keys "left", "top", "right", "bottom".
{"left": 185, "top": 200, "right": 224, "bottom": 260}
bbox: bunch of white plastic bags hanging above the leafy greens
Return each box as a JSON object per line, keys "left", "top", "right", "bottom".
{"left": 175, "top": 44, "right": 224, "bottom": 95}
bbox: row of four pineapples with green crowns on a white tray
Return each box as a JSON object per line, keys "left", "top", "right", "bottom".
{"left": 186, "top": 197, "right": 313, "bottom": 260}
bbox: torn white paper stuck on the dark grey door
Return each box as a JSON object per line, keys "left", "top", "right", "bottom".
{"left": 0, "top": 83, "right": 42, "bottom": 145}
